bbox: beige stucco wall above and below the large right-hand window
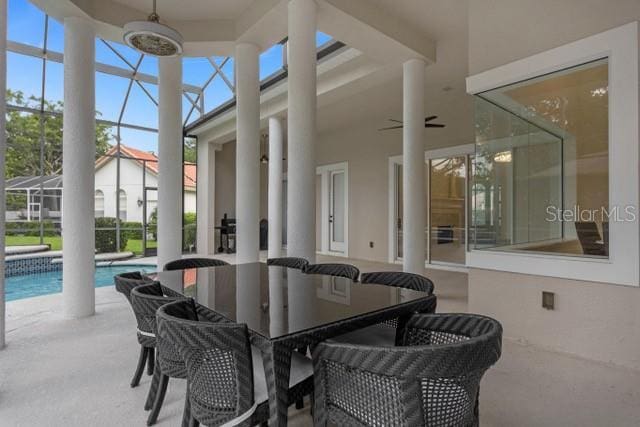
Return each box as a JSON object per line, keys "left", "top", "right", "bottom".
{"left": 469, "top": 0, "right": 640, "bottom": 369}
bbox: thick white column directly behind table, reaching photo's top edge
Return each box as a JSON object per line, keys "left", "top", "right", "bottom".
{"left": 287, "top": 0, "right": 317, "bottom": 262}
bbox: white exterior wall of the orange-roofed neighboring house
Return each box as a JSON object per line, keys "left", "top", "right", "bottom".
{"left": 96, "top": 159, "right": 196, "bottom": 222}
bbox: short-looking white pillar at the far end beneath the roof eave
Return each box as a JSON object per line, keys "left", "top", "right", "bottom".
{"left": 196, "top": 142, "right": 217, "bottom": 255}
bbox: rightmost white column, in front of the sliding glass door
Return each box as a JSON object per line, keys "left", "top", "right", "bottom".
{"left": 402, "top": 59, "right": 426, "bottom": 274}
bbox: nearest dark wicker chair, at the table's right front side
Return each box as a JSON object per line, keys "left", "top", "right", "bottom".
{"left": 313, "top": 314, "right": 502, "bottom": 427}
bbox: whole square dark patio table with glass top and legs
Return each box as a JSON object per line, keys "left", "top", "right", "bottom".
{"left": 156, "top": 263, "right": 436, "bottom": 427}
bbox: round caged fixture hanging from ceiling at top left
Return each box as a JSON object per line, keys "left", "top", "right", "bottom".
{"left": 124, "top": 0, "right": 183, "bottom": 57}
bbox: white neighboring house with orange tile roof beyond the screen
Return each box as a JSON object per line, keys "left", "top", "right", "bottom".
{"left": 95, "top": 144, "right": 196, "bottom": 222}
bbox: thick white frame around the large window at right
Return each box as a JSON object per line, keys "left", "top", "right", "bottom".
{"left": 467, "top": 22, "right": 640, "bottom": 286}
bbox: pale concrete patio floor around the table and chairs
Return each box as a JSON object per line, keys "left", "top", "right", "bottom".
{"left": 0, "top": 258, "right": 640, "bottom": 426}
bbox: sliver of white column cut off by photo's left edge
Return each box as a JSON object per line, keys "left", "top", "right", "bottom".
{"left": 0, "top": 0, "right": 7, "bottom": 349}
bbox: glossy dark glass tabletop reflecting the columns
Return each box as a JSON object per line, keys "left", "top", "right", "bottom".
{"left": 157, "top": 263, "right": 436, "bottom": 339}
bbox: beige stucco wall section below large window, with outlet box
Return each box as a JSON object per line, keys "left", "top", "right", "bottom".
{"left": 469, "top": 268, "right": 640, "bottom": 369}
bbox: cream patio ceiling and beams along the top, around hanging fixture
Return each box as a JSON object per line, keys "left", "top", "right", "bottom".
{"left": 34, "top": 0, "right": 436, "bottom": 63}
